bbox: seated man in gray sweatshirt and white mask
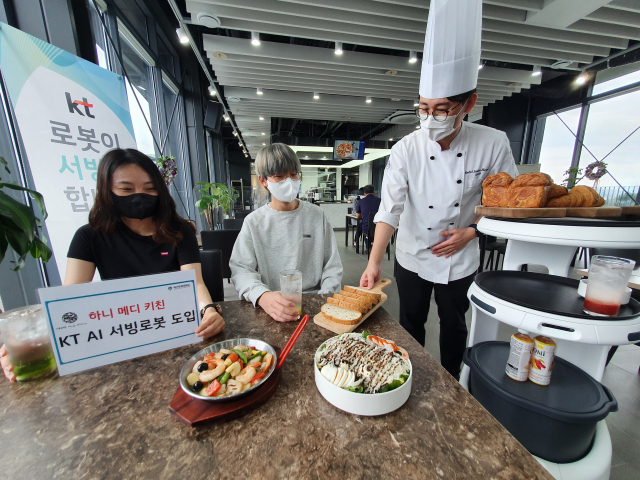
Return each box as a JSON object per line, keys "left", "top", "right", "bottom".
{"left": 229, "top": 143, "right": 342, "bottom": 322}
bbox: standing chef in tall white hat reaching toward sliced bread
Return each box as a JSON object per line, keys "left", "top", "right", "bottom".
{"left": 360, "top": 0, "right": 517, "bottom": 379}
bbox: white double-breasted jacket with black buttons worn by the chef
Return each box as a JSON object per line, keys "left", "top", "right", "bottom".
{"left": 374, "top": 122, "right": 518, "bottom": 284}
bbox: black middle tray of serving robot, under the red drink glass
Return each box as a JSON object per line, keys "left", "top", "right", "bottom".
{"left": 472, "top": 270, "right": 640, "bottom": 321}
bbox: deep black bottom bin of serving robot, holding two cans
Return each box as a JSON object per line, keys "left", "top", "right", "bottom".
{"left": 464, "top": 342, "right": 618, "bottom": 463}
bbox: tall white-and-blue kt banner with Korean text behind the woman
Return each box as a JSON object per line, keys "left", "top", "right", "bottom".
{"left": 0, "top": 22, "right": 136, "bottom": 278}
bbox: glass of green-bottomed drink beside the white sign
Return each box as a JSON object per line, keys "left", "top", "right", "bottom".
{"left": 0, "top": 305, "right": 57, "bottom": 382}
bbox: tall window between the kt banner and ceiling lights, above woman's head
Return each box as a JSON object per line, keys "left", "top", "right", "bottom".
{"left": 118, "top": 24, "right": 159, "bottom": 158}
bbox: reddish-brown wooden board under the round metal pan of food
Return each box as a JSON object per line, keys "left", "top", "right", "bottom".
{"left": 169, "top": 348, "right": 281, "bottom": 427}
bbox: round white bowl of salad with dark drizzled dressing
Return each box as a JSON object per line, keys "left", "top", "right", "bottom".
{"left": 314, "top": 332, "right": 413, "bottom": 416}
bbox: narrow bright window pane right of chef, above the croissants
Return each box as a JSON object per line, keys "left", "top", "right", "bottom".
{"left": 539, "top": 107, "right": 581, "bottom": 185}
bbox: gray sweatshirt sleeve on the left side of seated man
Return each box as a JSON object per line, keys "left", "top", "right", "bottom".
{"left": 229, "top": 226, "right": 270, "bottom": 307}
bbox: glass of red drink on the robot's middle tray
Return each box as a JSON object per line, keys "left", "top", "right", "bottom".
{"left": 583, "top": 255, "right": 636, "bottom": 317}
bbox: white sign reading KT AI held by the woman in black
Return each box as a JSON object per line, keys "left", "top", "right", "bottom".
{"left": 38, "top": 270, "right": 202, "bottom": 375}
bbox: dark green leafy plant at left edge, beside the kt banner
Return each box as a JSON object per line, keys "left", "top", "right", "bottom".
{"left": 0, "top": 157, "right": 51, "bottom": 271}
